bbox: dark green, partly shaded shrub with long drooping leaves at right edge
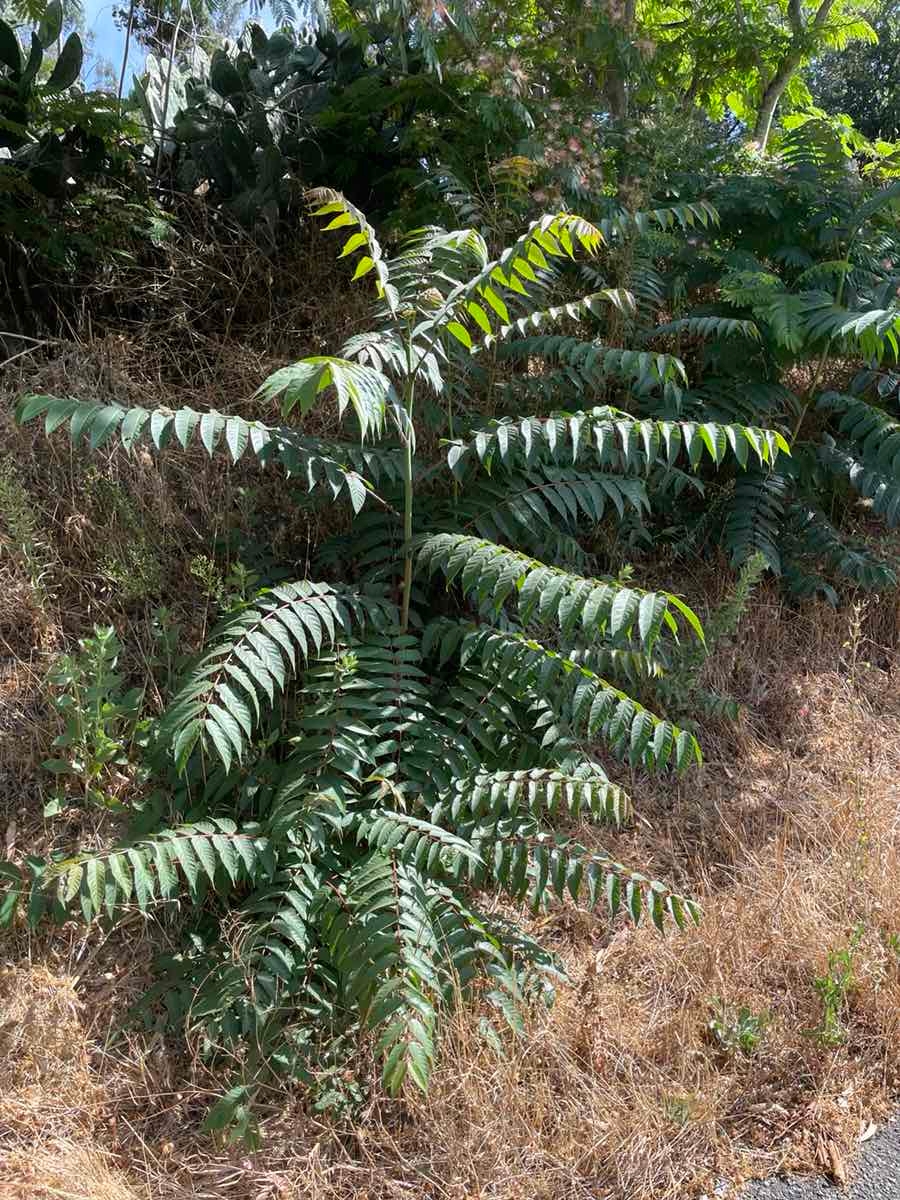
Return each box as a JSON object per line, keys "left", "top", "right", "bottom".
{"left": 642, "top": 120, "right": 900, "bottom": 602}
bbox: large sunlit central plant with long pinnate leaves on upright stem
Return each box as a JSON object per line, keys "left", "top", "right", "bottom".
{"left": 0, "top": 193, "right": 787, "bottom": 1134}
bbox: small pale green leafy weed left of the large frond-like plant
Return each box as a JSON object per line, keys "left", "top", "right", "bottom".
{"left": 43, "top": 626, "right": 143, "bottom": 816}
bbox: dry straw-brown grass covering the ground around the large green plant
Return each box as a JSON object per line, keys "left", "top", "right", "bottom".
{"left": 0, "top": 321, "right": 900, "bottom": 1200}
